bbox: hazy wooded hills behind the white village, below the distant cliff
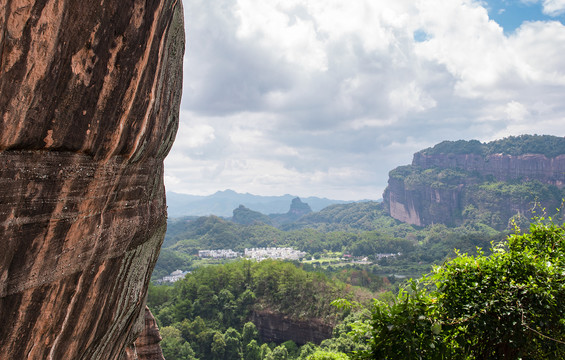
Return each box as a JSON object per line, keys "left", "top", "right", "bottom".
{"left": 153, "top": 202, "right": 504, "bottom": 282}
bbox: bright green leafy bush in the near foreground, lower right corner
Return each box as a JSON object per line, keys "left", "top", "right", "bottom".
{"left": 348, "top": 221, "right": 565, "bottom": 359}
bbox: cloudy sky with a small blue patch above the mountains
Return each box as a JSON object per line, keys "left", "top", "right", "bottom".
{"left": 165, "top": 0, "right": 565, "bottom": 200}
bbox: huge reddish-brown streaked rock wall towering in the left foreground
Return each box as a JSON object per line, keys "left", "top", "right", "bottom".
{"left": 0, "top": 0, "right": 184, "bottom": 359}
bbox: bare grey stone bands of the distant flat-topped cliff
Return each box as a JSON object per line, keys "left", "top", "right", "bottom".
{"left": 383, "top": 152, "right": 565, "bottom": 227}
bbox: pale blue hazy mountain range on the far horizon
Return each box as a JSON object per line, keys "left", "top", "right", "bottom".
{"left": 167, "top": 190, "right": 350, "bottom": 218}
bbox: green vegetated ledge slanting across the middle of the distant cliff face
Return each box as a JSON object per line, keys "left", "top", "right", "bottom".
{"left": 387, "top": 165, "right": 565, "bottom": 230}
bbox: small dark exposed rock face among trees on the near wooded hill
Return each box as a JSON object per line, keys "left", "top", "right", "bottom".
{"left": 251, "top": 311, "right": 333, "bottom": 345}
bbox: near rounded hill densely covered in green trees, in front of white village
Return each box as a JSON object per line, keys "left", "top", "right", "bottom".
{"left": 147, "top": 260, "right": 373, "bottom": 360}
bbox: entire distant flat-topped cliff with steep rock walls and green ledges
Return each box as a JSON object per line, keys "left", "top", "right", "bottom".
{"left": 383, "top": 136, "right": 565, "bottom": 229}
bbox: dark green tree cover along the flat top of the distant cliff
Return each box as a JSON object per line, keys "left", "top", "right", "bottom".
{"left": 420, "top": 135, "right": 565, "bottom": 158}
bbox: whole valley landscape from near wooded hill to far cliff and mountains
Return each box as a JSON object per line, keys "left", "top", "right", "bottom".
{"left": 148, "top": 136, "right": 565, "bottom": 360}
